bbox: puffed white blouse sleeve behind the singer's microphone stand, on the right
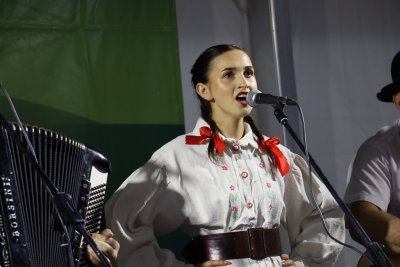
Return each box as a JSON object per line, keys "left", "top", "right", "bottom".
{"left": 283, "top": 153, "right": 345, "bottom": 267}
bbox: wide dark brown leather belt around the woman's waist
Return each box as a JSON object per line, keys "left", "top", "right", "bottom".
{"left": 182, "top": 228, "right": 282, "bottom": 264}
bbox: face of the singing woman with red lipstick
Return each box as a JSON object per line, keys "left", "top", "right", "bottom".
{"left": 196, "top": 49, "right": 257, "bottom": 121}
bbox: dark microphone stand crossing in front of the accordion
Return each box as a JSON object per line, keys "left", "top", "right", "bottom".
{"left": 0, "top": 113, "right": 112, "bottom": 267}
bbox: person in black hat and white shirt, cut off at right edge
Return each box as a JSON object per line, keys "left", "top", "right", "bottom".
{"left": 344, "top": 52, "right": 400, "bottom": 266}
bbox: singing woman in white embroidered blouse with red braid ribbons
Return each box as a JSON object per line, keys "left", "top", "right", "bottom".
{"left": 106, "top": 45, "right": 344, "bottom": 267}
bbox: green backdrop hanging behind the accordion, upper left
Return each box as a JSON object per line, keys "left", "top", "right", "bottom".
{"left": 0, "top": 0, "right": 189, "bottom": 260}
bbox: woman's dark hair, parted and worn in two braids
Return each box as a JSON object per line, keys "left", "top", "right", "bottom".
{"left": 190, "top": 44, "right": 274, "bottom": 165}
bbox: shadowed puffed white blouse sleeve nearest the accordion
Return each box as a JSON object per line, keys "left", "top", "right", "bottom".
{"left": 106, "top": 154, "right": 192, "bottom": 267}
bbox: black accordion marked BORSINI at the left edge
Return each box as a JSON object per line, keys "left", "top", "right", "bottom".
{"left": 0, "top": 123, "right": 110, "bottom": 267}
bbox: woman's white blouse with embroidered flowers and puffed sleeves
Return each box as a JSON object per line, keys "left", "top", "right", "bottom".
{"left": 106, "top": 119, "right": 344, "bottom": 267}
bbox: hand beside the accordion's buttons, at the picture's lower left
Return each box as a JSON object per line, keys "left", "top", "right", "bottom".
{"left": 87, "top": 229, "right": 119, "bottom": 267}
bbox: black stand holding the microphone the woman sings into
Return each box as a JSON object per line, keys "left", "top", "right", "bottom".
{"left": 273, "top": 104, "right": 393, "bottom": 267}
